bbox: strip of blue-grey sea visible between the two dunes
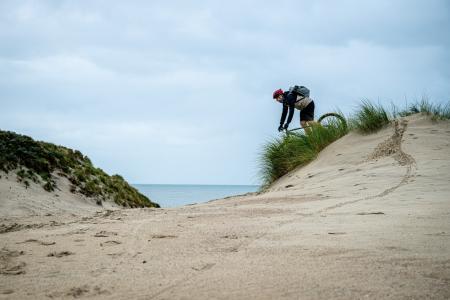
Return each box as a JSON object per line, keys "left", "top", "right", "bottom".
{"left": 133, "top": 184, "right": 259, "bottom": 207}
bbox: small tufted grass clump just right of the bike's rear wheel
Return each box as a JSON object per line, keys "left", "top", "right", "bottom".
{"left": 350, "top": 100, "right": 390, "bottom": 134}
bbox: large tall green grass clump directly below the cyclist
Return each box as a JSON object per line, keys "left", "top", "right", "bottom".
{"left": 260, "top": 118, "right": 348, "bottom": 190}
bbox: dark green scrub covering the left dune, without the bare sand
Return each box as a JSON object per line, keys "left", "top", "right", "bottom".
{"left": 0, "top": 130, "right": 159, "bottom": 207}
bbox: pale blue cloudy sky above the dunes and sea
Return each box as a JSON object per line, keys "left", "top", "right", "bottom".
{"left": 0, "top": 0, "right": 450, "bottom": 184}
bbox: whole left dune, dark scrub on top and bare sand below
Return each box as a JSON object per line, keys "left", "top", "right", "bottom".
{"left": 0, "top": 130, "right": 159, "bottom": 216}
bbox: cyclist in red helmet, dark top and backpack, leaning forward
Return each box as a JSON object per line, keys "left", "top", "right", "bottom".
{"left": 273, "top": 86, "right": 314, "bottom": 131}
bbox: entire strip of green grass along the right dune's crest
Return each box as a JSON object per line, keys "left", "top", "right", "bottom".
{"left": 259, "top": 99, "right": 450, "bottom": 190}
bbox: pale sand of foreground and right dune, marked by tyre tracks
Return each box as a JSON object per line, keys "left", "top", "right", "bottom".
{"left": 0, "top": 116, "right": 450, "bottom": 299}
